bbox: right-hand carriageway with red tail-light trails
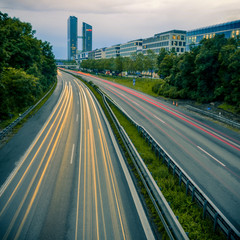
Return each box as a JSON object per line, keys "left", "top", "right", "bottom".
{"left": 73, "top": 72, "right": 240, "bottom": 230}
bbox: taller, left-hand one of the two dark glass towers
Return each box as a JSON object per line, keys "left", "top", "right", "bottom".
{"left": 67, "top": 16, "right": 78, "bottom": 60}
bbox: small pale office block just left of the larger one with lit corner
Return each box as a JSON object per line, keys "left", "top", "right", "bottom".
{"left": 120, "top": 39, "right": 142, "bottom": 57}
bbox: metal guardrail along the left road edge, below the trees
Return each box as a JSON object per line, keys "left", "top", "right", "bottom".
{"left": 0, "top": 84, "right": 55, "bottom": 140}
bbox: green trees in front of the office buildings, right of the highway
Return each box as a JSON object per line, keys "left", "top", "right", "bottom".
{"left": 81, "top": 35, "right": 240, "bottom": 111}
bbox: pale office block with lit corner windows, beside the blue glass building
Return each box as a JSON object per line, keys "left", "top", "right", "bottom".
{"left": 142, "top": 30, "right": 186, "bottom": 55}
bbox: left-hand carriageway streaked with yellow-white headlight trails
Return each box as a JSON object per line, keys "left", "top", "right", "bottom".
{"left": 0, "top": 72, "right": 155, "bottom": 239}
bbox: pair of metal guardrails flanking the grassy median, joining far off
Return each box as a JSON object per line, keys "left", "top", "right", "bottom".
{"left": 96, "top": 87, "right": 240, "bottom": 240}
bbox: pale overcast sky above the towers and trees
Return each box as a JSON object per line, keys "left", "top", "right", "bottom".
{"left": 0, "top": 0, "right": 240, "bottom": 59}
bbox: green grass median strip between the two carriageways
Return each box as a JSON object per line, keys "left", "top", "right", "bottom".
{"left": 76, "top": 76, "right": 226, "bottom": 240}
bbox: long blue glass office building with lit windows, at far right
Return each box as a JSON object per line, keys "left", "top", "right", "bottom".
{"left": 186, "top": 20, "right": 240, "bottom": 51}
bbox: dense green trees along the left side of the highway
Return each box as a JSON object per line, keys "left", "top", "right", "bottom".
{"left": 0, "top": 12, "right": 57, "bottom": 120}
